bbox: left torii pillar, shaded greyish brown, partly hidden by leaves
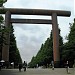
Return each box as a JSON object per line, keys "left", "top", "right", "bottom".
{"left": 2, "top": 11, "right": 11, "bottom": 66}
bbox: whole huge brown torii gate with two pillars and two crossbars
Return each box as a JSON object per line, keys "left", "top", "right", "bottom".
{"left": 0, "top": 8, "right": 71, "bottom": 67}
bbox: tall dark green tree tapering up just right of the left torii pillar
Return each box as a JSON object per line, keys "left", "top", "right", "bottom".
{"left": 9, "top": 25, "right": 22, "bottom": 66}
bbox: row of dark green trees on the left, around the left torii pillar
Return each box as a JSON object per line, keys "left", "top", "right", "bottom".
{"left": 0, "top": 0, "right": 22, "bottom": 67}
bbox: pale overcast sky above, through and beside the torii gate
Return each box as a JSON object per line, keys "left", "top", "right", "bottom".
{"left": 4, "top": 0, "right": 75, "bottom": 62}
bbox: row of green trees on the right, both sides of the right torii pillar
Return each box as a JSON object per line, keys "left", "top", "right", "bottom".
{"left": 28, "top": 19, "right": 75, "bottom": 68}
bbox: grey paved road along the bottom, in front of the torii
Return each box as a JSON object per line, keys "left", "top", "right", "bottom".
{"left": 0, "top": 68, "right": 75, "bottom": 75}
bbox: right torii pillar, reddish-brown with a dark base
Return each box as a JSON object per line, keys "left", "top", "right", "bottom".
{"left": 52, "top": 13, "right": 60, "bottom": 67}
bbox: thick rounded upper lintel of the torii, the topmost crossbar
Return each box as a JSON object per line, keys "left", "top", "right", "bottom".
{"left": 0, "top": 8, "right": 71, "bottom": 17}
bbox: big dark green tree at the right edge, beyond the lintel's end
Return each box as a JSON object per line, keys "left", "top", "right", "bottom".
{"left": 63, "top": 19, "right": 75, "bottom": 67}
